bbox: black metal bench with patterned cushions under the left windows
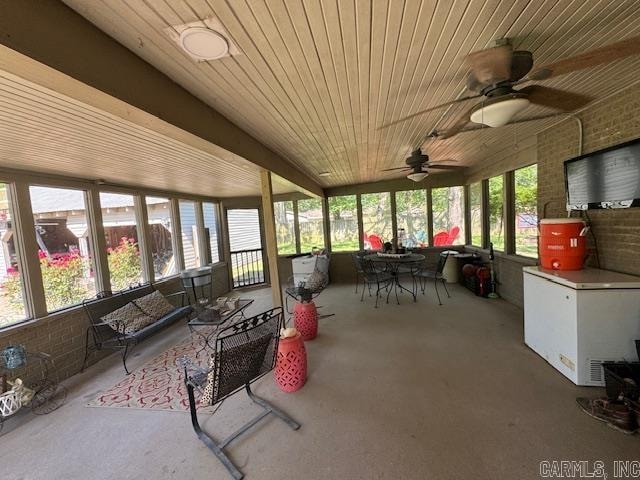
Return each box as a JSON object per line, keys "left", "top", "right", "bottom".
{"left": 81, "top": 284, "right": 193, "bottom": 375}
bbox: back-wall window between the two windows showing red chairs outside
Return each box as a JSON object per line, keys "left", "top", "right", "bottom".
{"left": 396, "top": 190, "right": 429, "bottom": 248}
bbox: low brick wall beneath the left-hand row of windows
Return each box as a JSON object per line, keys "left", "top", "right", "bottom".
{"left": 0, "top": 264, "right": 229, "bottom": 381}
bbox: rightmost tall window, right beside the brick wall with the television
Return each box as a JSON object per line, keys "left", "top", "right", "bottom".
{"left": 514, "top": 165, "right": 538, "bottom": 257}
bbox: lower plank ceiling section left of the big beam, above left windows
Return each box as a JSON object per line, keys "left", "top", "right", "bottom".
{"left": 0, "top": 67, "right": 284, "bottom": 197}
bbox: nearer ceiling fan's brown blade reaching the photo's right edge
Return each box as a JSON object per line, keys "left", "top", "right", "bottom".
{"left": 529, "top": 35, "right": 640, "bottom": 80}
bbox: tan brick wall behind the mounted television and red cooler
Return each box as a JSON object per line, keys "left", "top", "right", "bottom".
{"left": 538, "top": 84, "right": 640, "bottom": 275}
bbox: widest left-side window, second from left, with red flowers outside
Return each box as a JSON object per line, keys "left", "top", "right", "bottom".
{"left": 29, "top": 186, "right": 96, "bottom": 312}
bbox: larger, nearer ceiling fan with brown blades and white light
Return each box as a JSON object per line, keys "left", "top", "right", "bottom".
{"left": 382, "top": 35, "right": 640, "bottom": 138}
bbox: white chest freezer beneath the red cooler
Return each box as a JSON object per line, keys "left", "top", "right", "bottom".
{"left": 523, "top": 267, "right": 640, "bottom": 386}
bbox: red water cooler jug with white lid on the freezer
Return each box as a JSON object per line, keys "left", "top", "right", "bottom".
{"left": 540, "top": 218, "right": 588, "bottom": 270}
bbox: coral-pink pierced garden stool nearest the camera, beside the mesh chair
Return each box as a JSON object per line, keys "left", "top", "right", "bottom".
{"left": 275, "top": 332, "right": 307, "bottom": 393}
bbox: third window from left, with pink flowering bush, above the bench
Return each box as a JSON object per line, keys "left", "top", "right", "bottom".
{"left": 100, "top": 192, "right": 143, "bottom": 291}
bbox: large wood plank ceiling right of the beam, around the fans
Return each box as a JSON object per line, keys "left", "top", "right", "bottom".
{"left": 64, "top": 0, "right": 640, "bottom": 186}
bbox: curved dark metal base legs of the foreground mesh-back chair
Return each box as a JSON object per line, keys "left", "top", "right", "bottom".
{"left": 185, "top": 382, "right": 300, "bottom": 480}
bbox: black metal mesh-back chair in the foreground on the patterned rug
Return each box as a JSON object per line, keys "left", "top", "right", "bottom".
{"left": 183, "top": 307, "right": 300, "bottom": 480}
